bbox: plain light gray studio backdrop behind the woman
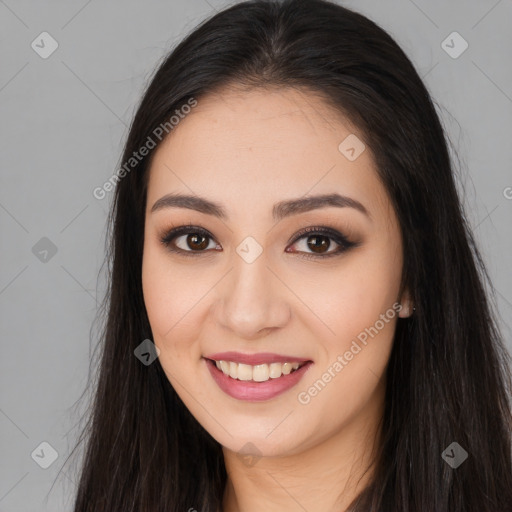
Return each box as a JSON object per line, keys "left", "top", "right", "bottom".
{"left": 0, "top": 0, "right": 512, "bottom": 512}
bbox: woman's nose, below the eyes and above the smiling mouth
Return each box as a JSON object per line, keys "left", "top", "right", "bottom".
{"left": 215, "top": 252, "right": 291, "bottom": 340}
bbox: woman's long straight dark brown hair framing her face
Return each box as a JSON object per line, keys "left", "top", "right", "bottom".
{"left": 63, "top": 0, "right": 512, "bottom": 512}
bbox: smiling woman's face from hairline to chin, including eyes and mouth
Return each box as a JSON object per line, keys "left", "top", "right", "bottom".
{"left": 142, "top": 89, "right": 410, "bottom": 455}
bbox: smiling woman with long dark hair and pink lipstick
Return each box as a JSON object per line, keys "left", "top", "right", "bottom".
{"left": 68, "top": 0, "right": 512, "bottom": 512}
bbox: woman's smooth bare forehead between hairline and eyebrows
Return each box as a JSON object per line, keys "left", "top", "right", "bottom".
{"left": 148, "top": 88, "right": 387, "bottom": 222}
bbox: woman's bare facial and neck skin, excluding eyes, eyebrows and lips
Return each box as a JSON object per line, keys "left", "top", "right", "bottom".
{"left": 142, "top": 88, "right": 412, "bottom": 512}
